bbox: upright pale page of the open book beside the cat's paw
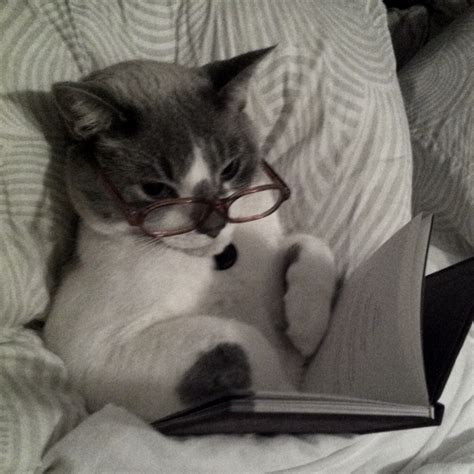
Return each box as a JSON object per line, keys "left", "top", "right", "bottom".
{"left": 304, "top": 215, "right": 431, "bottom": 405}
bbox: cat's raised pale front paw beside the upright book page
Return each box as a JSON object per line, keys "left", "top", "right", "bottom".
{"left": 285, "top": 235, "right": 336, "bottom": 357}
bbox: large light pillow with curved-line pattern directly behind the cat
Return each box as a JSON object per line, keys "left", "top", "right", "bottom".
{"left": 0, "top": 0, "right": 412, "bottom": 471}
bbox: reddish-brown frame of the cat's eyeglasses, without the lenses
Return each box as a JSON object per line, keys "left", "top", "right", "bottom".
{"left": 99, "top": 160, "right": 291, "bottom": 239}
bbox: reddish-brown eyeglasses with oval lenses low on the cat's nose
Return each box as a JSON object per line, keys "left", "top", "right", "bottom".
{"left": 99, "top": 160, "right": 291, "bottom": 239}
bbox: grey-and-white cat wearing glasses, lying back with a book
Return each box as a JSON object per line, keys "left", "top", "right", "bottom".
{"left": 44, "top": 48, "right": 336, "bottom": 421}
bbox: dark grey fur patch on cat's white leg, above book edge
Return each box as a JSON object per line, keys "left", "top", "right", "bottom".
{"left": 177, "top": 343, "right": 251, "bottom": 404}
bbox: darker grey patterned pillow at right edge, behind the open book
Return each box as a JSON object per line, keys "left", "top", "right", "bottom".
{"left": 399, "top": 7, "right": 474, "bottom": 256}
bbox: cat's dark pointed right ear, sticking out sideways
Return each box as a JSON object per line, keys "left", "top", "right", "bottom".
{"left": 202, "top": 45, "right": 276, "bottom": 110}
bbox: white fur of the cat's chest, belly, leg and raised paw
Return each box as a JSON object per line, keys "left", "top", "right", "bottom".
{"left": 45, "top": 196, "right": 335, "bottom": 420}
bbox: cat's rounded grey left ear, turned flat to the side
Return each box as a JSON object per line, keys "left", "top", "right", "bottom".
{"left": 52, "top": 82, "right": 124, "bottom": 140}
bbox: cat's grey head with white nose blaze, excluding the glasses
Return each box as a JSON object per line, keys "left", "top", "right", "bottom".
{"left": 53, "top": 48, "right": 273, "bottom": 254}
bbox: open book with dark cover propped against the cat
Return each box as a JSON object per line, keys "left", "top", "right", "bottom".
{"left": 153, "top": 214, "right": 474, "bottom": 434}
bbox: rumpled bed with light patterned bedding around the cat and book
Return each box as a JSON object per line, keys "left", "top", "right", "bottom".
{"left": 0, "top": 0, "right": 474, "bottom": 473}
